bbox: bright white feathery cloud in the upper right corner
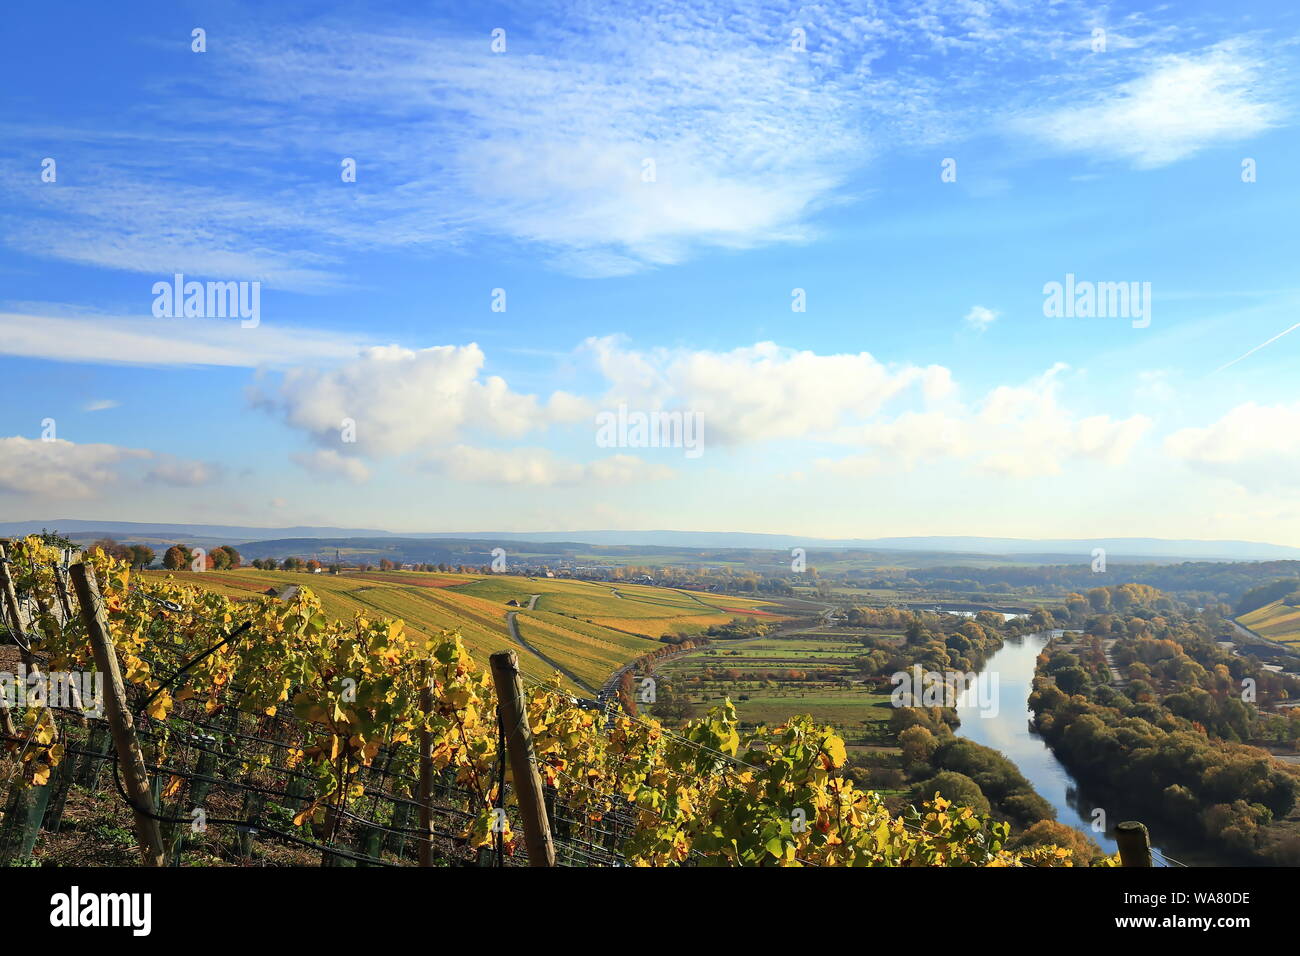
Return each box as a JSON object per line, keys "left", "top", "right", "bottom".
{"left": 1019, "top": 42, "right": 1281, "bottom": 168}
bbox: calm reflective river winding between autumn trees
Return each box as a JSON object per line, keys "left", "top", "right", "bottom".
{"left": 957, "top": 633, "right": 1225, "bottom": 865}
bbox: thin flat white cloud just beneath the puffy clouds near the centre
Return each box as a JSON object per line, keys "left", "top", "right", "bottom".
{"left": 428, "top": 445, "right": 675, "bottom": 486}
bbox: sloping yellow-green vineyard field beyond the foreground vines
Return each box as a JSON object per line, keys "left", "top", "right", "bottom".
{"left": 143, "top": 568, "right": 770, "bottom": 689}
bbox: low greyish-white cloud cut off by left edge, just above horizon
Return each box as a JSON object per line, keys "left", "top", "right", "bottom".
{"left": 0, "top": 436, "right": 151, "bottom": 498}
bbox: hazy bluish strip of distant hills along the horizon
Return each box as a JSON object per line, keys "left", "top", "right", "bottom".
{"left": 0, "top": 518, "right": 1300, "bottom": 563}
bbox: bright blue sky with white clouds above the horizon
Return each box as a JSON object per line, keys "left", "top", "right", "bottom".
{"left": 0, "top": 0, "right": 1300, "bottom": 545}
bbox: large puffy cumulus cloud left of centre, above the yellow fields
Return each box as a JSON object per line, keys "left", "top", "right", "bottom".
{"left": 252, "top": 343, "right": 590, "bottom": 464}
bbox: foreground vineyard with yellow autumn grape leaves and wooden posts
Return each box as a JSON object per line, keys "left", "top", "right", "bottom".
{"left": 0, "top": 537, "right": 1073, "bottom": 866}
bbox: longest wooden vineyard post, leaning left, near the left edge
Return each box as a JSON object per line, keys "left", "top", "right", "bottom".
{"left": 70, "top": 561, "right": 166, "bottom": 866}
